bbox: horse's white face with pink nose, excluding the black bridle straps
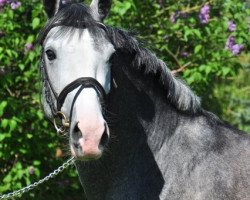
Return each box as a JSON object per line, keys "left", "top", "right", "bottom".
{"left": 44, "top": 27, "right": 115, "bottom": 159}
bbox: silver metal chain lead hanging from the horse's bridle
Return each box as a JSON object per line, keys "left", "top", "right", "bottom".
{"left": 0, "top": 157, "right": 75, "bottom": 200}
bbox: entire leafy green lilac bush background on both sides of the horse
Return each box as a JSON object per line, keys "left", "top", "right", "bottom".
{"left": 0, "top": 0, "right": 250, "bottom": 200}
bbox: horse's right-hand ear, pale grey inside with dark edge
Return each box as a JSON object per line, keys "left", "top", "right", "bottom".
{"left": 90, "top": 0, "right": 112, "bottom": 21}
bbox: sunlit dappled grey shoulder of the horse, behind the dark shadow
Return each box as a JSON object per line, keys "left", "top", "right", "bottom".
{"left": 161, "top": 115, "right": 250, "bottom": 199}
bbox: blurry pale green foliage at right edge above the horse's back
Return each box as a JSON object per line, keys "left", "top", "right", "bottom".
{"left": 214, "top": 67, "right": 250, "bottom": 133}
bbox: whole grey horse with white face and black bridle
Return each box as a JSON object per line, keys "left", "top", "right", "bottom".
{"left": 39, "top": 0, "right": 250, "bottom": 200}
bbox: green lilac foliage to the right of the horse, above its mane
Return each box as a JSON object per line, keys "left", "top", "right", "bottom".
{"left": 107, "top": 0, "right": 250, "bottom": 131}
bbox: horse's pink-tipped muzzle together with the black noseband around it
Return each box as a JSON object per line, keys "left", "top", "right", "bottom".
{"left": 49, "top": 77, "right": 109, "bottom": 160}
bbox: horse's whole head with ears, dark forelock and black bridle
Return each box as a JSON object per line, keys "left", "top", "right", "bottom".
{"left": 40, "top": 0, "right": 115, "bottom": 160}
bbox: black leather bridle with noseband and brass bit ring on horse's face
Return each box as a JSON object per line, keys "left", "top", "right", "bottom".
{"left": 41, "top": 22, "right": 107, "bottom": 134}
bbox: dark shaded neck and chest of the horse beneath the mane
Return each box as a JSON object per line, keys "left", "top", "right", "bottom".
{"left": 77, "top": 59, "right": 188, "bottom": 199}
